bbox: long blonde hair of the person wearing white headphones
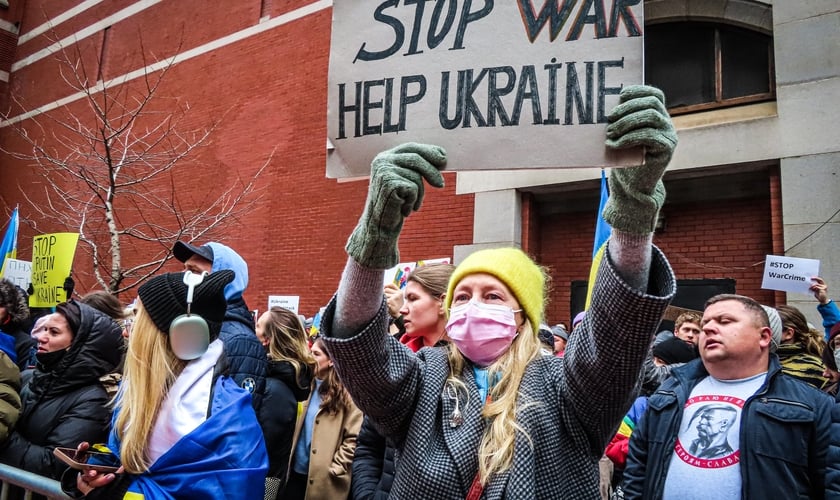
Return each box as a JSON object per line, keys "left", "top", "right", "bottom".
{"left": 114, "top": 301, "right": 187, "bottom": 474}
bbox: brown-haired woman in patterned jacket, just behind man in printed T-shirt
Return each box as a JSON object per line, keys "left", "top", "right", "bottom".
{"left": 776, "top": 305, "right": 828, "bottom": 389}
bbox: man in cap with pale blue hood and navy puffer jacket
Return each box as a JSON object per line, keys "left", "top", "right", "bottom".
{"left": 172, "top": 241, "right": 268, "bottom": 415}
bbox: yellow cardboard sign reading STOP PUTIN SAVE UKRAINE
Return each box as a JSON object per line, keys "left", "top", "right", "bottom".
{"left": 29, "top": 233, "right": 79, "bottom": 307}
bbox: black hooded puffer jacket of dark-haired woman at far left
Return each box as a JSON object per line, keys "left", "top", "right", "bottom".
{"left": 0, "top": 304, "right": 123, "bottom": 479}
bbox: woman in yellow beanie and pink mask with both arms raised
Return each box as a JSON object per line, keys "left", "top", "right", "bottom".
{"left": 322, "top": 86, "right": 677, "bottom": 499}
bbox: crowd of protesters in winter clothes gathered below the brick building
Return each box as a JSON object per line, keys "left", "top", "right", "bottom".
{"left": 0, "top": 86, "right": 840, "bottom": 500}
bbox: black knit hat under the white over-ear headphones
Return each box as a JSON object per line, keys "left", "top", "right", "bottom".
{"left": 137, "top": 269, "right": 236, "bottom": 341}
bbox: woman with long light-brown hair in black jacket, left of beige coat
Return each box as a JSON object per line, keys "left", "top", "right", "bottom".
{"left": 256, "top": 306, "right": 315, "bottom": 498}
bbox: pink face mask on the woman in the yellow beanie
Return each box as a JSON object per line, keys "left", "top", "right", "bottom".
{"left": 446, "top": 301, "right": 521, "bottom": 366}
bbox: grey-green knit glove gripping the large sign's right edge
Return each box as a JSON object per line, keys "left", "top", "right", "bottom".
{"left": 603, "top": 85, "right": 677, "bottom": 235}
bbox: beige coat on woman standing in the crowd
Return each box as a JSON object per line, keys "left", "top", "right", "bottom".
{"left": 292, "top": 384, "right": 362, "bottom": 500}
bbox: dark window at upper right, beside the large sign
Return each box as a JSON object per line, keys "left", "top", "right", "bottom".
{"left": 645, "top": 22, "right": 775, "bottom": 114}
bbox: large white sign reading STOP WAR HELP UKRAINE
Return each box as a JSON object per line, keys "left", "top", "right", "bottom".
{"left": 327, "top": 0, "right": 644, "bottom": 178}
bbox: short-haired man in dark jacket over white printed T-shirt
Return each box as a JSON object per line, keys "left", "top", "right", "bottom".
{"left": 623, "top": 294, "right": 833, "bottom": 500}
